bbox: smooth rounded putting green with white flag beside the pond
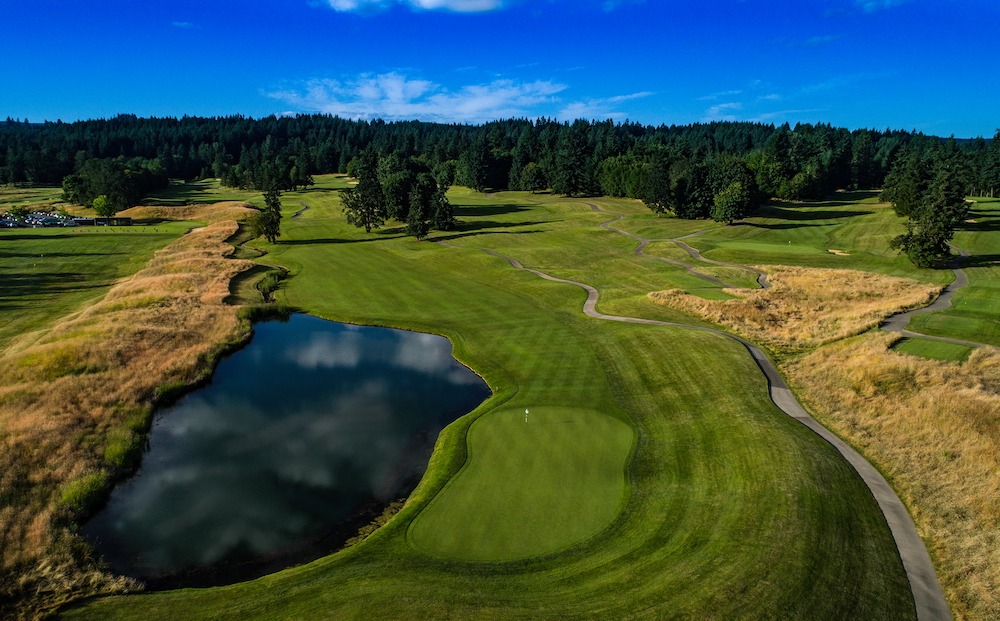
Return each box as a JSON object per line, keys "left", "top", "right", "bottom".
{"left": 410, "top": 407, "right": 635, "bottom": 561}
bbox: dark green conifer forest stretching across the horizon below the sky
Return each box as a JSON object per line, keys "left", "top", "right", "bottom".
{"left": 0, "top": 115, "right": 1000, "bottom": 264}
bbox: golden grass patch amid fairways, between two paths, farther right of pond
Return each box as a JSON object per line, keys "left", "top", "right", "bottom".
{"left": 649, "top": 266, "right": 941, "bottom": 351}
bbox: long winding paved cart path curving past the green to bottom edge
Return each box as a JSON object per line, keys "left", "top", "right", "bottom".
{"left": 466, "top": 242, "right": 951, "bottom": 621}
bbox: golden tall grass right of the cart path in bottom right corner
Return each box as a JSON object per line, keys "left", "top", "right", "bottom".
{"left": 784, "top": 334, "right": 1000, "bottom": 619}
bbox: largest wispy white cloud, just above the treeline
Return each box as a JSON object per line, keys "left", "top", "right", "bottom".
{"left": 267, "top": 72, "right": 566, "bottom": 123}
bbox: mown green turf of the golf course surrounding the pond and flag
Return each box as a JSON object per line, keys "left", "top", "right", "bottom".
{"left": 3, "top": 176, "right": 1000, "bottom": 619}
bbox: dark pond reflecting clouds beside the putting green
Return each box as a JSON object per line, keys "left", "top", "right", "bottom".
{"left": 84, "top": 314, "right": 490, "bottom": 587}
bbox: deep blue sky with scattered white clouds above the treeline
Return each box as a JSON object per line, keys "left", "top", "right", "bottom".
{"left": 0, "top": 0, "right": 1000, "bottom": 137}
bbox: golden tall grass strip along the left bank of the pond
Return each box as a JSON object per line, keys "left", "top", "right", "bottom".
{"left": 0, "top": 220, "right": 253, "bottom": 617}
